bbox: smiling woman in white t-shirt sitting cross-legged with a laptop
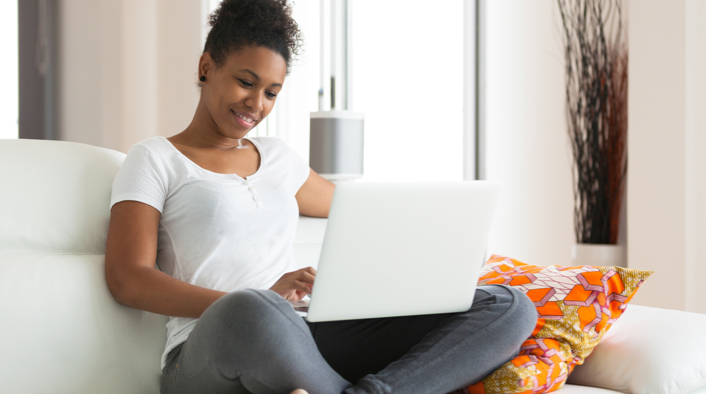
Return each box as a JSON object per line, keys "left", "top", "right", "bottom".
{"left": 106, "top": 0, "right": 536, "bottom": 394}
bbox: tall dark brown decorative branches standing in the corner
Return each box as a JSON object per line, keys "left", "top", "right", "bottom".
{"left": 557, "top": 0, "right": 628, "bottom": 244}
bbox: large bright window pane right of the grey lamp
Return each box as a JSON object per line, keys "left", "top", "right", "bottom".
{"left": 351, "top": 0, "right": 464, "bottom": 181}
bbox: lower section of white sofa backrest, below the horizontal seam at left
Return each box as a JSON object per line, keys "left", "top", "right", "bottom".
{"left": 0, "top": 253, "right": 167, "bottom": 394}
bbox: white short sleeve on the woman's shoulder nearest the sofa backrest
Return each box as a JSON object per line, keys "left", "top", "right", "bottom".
{"left": 110, "top": 145, "right": 167, "bottom": 212}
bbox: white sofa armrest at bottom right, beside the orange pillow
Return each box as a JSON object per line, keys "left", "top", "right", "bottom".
{"left": 568, "top": 305, "right": 706, "bottom": 394}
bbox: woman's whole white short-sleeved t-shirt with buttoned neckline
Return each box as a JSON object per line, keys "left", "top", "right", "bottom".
{"left": 110, "top": 137, "right": 309, "bottom": 368}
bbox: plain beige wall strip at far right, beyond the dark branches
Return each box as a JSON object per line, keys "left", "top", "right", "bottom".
{"left": 628, "top": 0, "right": 706, "bottom": 313}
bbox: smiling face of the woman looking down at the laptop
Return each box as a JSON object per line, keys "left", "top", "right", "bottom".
{"left": 199, "top": 46, "right": 287, "bottom": 139}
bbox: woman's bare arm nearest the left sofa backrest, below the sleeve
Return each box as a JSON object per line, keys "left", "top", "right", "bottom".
{"left": 105, "top": 201, "right": 226, "bottom": 317}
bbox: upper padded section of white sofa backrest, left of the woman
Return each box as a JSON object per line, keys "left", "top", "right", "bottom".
{"left": 0, "top": 140, "right": 125, "bottom": 254}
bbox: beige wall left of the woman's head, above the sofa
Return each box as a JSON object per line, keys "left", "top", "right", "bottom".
{"left": 58, "top": 0, "right": 205, "bottom": 152}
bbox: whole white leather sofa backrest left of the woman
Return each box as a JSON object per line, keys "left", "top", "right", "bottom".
{"left": 0, "top": 140, "right": 166, "bottom": 394}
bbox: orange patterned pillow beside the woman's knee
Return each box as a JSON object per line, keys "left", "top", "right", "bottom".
{"left": 462, "top": 255, "right": 652, "bottom": 394}
